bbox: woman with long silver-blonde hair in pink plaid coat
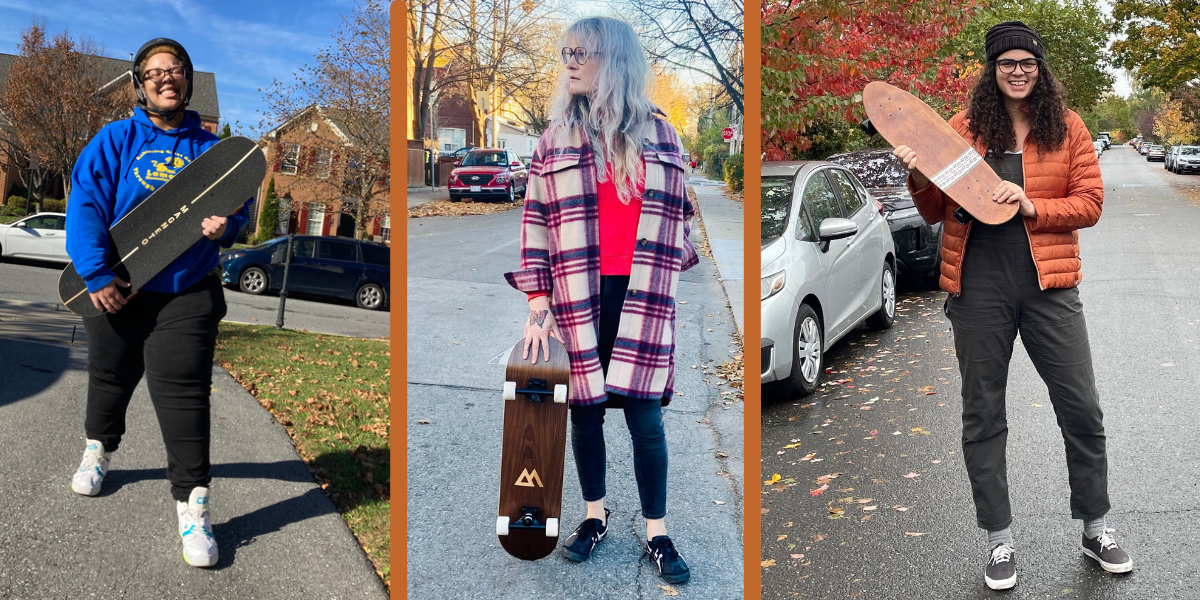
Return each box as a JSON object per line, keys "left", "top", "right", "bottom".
{"left": 505, "top": 17, "right": 698, "bottom": 583}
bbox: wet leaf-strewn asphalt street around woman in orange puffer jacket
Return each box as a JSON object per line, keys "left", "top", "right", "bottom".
{"left": 758, "top": 146, "right": 1200, "bottom": 599}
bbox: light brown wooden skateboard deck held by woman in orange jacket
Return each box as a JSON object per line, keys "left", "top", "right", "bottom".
{"left": 863, "top": 82, "right": 1019, "bottom": 224}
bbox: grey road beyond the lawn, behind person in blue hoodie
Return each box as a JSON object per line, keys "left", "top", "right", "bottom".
{"left": 0, "top": 260, "right": 391, "bottom": 341}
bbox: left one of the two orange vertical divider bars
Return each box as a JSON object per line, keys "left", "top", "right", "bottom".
{"left": 388, "top": 1, "right": 408, "bottom": 600}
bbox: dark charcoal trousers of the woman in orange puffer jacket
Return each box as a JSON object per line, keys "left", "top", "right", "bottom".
{"left": 946, "top": 222, "right": 1109, "bottom": 530}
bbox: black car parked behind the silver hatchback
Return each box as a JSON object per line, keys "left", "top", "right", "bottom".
{"left": 827, "top": 149, "right": 942, "bottom": 287}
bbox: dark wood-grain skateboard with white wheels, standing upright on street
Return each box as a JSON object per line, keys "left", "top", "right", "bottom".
{"left": 496, "top": 338, "right": 571, "bottom": 560}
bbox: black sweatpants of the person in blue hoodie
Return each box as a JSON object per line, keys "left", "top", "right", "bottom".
{"left": 83, "top": 275, "right": 226, "bottom": 502}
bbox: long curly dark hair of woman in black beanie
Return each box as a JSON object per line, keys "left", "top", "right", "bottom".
{"left": 966, "top": 60, "right": 1067, "bottom": 151}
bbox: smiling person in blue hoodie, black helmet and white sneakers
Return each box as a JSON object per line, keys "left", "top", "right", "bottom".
{"left": 67, "top": 38, "right": 253, "bottom": 566}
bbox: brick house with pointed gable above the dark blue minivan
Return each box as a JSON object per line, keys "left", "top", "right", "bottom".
{"left": 251, "top": 104, "right": 391, "bottom": 245}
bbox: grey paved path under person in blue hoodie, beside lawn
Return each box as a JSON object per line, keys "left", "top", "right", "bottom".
{"left": 0, "top": 336, "right": 386, "bottom": 599}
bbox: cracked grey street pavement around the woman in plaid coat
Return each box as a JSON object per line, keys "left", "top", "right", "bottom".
{"left": 406, "top": 196, "right": 744, "bottom": 599}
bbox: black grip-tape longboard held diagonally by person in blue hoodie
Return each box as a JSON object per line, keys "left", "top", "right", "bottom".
{"left": 59, "top": 136, "right": 266, "bottom": 317}
